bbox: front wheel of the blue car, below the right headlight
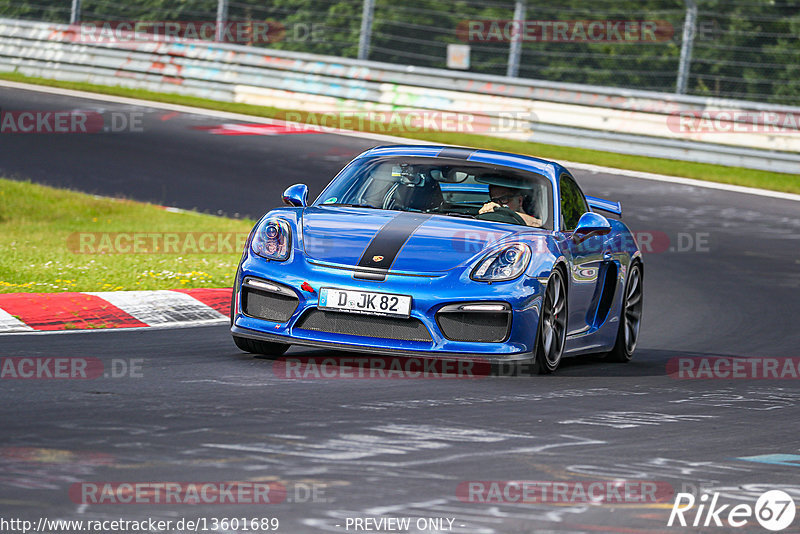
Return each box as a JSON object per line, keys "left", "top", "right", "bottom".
{"left": 533, "top": 268, "right": 568, "bottom": 375}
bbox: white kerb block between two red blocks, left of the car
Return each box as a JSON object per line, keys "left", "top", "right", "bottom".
{"left": 86, "top": 290, "right": 225, "bottom": 326}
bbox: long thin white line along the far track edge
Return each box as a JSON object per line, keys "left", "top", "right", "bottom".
{"left": 0, "top": 80, "right": 800, "bottom": 202}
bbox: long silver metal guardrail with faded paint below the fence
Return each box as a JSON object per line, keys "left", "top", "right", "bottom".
{"left": 0, "top": 19, "right": 800, "bottom": 174}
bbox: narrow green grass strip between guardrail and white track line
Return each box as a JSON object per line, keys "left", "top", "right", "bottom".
{"left": 0, "top": 73, "right": 800, "bottom": 193}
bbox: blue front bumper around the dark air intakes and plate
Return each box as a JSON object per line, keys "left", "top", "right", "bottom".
{"left": 231, "top": 254, "right": 543, "bottom": 362}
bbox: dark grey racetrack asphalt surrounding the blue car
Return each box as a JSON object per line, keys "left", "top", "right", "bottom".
{"left": 0, "top": 89, "right": 800, "bottom": 533}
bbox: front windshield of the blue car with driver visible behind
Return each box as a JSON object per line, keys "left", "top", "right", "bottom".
{"left": 314, "top": 156, "right": 553, "bottom": 230}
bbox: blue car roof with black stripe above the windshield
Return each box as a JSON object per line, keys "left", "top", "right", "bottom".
{"left": 356, "top": 145, "right": 570, "bottom": 185}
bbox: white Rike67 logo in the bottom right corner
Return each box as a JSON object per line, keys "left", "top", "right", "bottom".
{"left": 667, "top": 490, "right": 796, "bottom": 532}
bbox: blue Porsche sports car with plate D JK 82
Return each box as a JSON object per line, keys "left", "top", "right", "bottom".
{"left": 231, "top": 145, "right": 644, "bottom": 373}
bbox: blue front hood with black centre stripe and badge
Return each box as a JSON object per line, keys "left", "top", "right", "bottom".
{"left": 302, "top": 206, "right": 542, "bottom": 272}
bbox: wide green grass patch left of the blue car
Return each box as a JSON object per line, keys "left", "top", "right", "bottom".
{"left": 0, "top": 178, "right": 253, "bottom": 293}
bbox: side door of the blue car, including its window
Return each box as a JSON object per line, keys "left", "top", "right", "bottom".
{"left": 559, "top": 173, "right": 606, "bottom": 335}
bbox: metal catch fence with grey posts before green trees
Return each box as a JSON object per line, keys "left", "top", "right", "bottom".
{"left": 0, "top": 0, "right": 800, "bottom": 105}
